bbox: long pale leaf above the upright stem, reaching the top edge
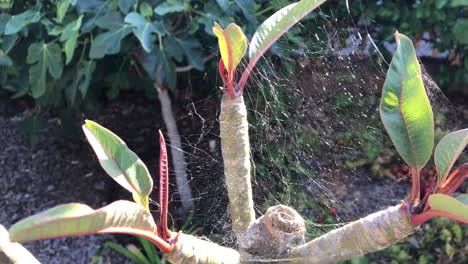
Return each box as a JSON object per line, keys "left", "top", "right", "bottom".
{"left": 249, "top": 0, "right": 325, "bottom": 62}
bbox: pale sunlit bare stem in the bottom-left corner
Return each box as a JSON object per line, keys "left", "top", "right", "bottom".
{"left": 0, "top": 225, "right": 41, "bottom": 264}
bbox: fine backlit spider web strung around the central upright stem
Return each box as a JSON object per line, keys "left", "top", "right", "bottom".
{"left": 156, "top": 4, "right": 466, "bottom": 258}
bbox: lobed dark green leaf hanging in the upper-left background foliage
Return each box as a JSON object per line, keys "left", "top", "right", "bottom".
{"left": 26, "top": 42, "right": 63, "bottom": 98}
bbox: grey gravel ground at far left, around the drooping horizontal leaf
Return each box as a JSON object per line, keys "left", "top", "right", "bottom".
{"left": 0, "top": 115, "right": 132, "bottom": 264}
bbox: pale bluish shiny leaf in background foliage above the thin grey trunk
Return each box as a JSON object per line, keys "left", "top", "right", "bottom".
{"left": 124, "top": 12, "right": 155, "bottom": 52}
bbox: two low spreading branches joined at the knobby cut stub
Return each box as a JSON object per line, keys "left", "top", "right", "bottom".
{"left": 164, "top": 205, "right": 416, "bottom": 264}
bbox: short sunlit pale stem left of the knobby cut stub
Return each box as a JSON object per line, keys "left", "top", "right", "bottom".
{"left": 163, "top": 233, "right": 240, "bottom": 264}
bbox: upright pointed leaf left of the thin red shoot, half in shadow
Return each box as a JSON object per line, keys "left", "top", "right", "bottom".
{"left": 83, "top": 120, "right": 153, "bottom": 208}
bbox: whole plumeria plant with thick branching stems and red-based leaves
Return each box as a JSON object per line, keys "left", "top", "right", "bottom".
{"left": 3, "top": 0, "right": 468, "bottom": 263}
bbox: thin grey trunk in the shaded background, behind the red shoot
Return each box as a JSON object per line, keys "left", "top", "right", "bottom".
{"left": 154, "top": 84, "right": 194, "bottom": 214}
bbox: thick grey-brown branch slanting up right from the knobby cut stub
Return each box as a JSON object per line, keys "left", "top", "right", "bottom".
{"left": 290, "top": 205, "right": 416, "bottom": 264}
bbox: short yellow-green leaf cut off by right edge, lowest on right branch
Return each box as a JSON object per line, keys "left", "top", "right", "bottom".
{"left": 429, "top": 194, "right": 468, "bottom": 223}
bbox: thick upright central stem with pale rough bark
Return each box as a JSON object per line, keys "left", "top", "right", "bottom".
{"left": 219, "top": 93, "right": 255, "bottom": 237}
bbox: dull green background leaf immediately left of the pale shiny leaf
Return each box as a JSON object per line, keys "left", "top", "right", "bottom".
{"left": 89, "top": 25, "right": 132, "bottom": 59}
